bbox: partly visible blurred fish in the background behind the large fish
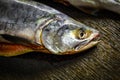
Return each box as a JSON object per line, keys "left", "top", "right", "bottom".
{"left": 54, "top": 0, "right": 120, "bottom": 14}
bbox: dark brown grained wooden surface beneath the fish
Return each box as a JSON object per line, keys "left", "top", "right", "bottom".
{"left": 0, "top": 0, "right": 120, "bottom": 80}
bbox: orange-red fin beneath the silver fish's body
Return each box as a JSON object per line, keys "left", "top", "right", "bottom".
{"left": 0, "top": 43, "right": 33, "bottom": 57}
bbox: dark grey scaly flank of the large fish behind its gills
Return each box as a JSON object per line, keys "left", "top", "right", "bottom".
{"left": 0, "top": 1, "right": 55, "bottom": 43}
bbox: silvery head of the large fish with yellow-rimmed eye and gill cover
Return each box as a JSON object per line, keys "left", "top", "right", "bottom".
{"left": 42, "top": 19, "right": 99, "bottom": 55}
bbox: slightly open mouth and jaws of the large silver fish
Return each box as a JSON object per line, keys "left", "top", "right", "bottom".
{"left": 75, "top": 33, "right": 100, "bottom": 52}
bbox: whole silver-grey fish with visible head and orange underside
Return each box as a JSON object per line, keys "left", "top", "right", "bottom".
{"left": 0, "top": 0, "right": 99, "bottom": 57}
